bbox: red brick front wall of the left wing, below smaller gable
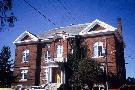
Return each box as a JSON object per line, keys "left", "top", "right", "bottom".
{"left": 13, "top": 44, "right": 37, "bottom": 86}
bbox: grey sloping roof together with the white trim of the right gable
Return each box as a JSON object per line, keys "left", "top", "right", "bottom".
{"left": 37, "top": 19, "right": 117, "bottom": 39}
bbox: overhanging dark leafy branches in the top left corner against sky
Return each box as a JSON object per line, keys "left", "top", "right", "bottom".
{"left": 0, "top": 0, "right": 17, "bottom": 31}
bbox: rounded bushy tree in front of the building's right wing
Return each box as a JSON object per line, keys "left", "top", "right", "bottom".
{"left": 72, "top": 59, "right": 106, "bottom": 90}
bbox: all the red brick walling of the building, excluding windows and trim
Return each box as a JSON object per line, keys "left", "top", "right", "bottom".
{"left": 14, "top": 34, "right": 124, "bottom": 86}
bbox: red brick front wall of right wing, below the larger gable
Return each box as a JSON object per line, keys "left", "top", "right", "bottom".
{"left": 84, "top": 34, "right": 117, "bottom": 74}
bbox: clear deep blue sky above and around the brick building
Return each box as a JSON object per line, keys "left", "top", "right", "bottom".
{"left": 0, "top": 0, "right": 135, "bottom": 77}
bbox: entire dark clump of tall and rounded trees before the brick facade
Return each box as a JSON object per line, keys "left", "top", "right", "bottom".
{"left": 58, "top": 35, "right": 105, "bottom": 90}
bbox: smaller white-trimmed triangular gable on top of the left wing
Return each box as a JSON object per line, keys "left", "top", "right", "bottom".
{"left": 13, "top": 31, "right": 38, "bottom": 44}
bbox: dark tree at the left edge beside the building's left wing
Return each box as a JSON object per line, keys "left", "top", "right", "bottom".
{"left": 0, "top": 46, "right": 13, "bottom": 87}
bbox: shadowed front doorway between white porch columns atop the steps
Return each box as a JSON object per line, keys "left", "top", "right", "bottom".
{"left": 52, "top": 67, "right": 61, "bottom": 83}
